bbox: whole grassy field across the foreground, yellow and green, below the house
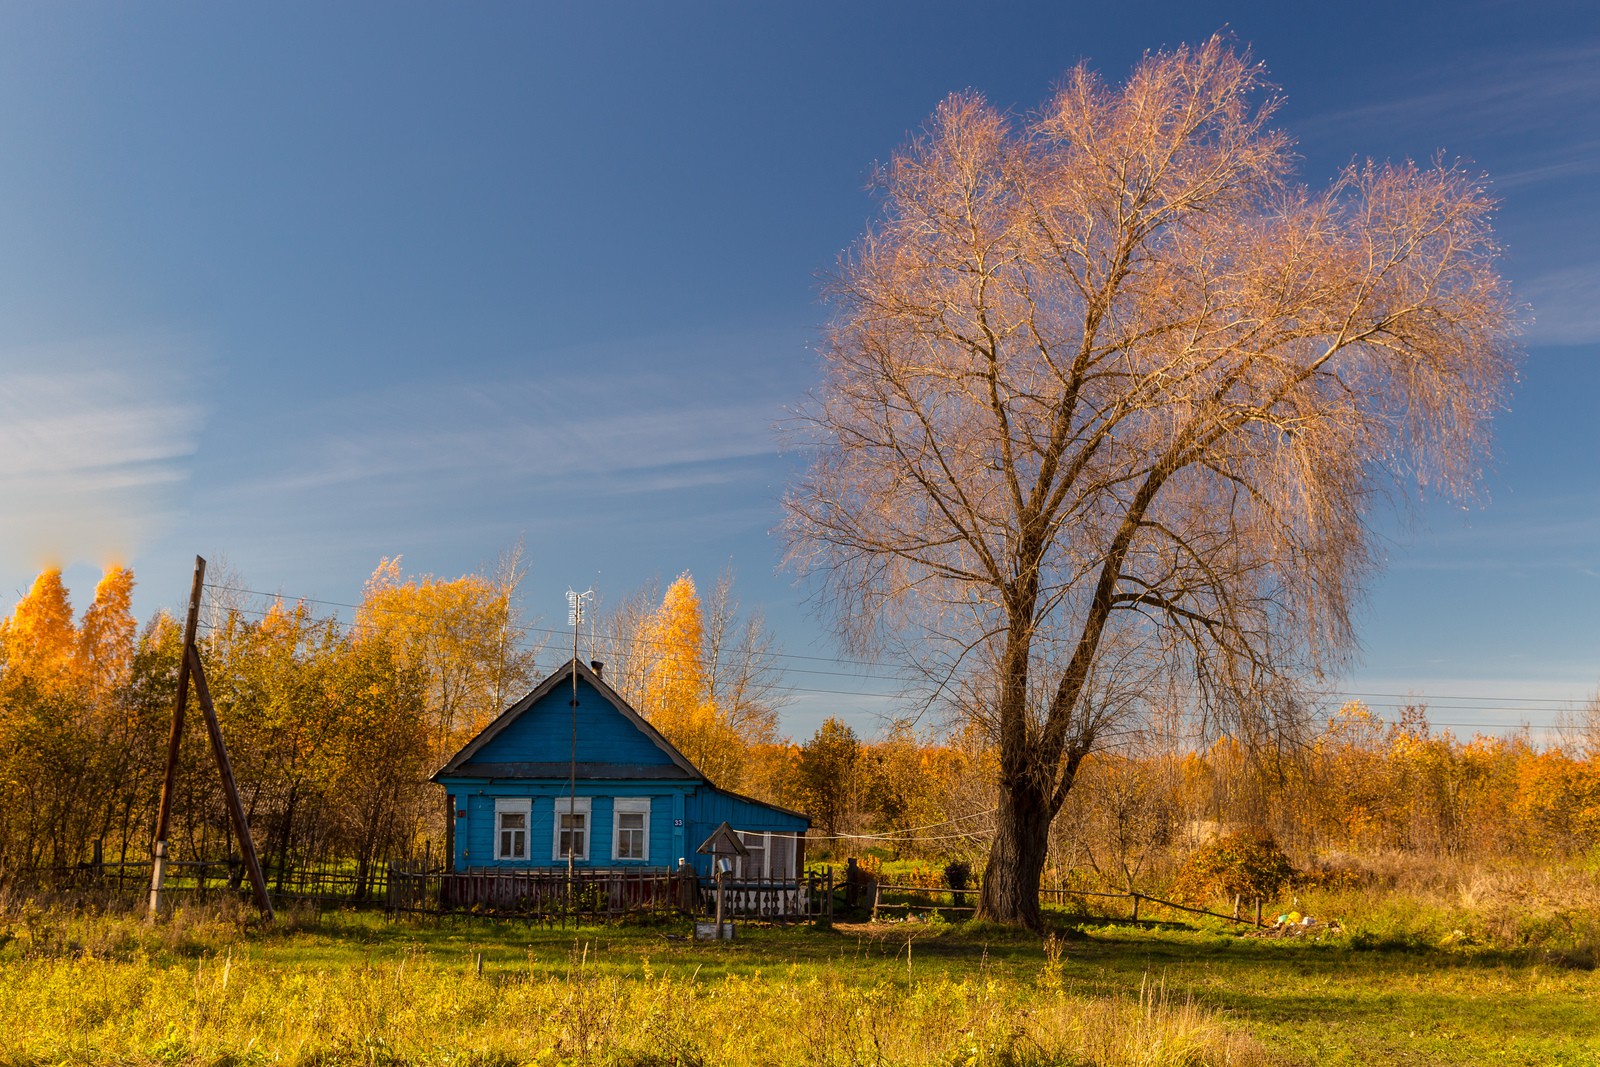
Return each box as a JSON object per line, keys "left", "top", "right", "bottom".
{"left": 0, "top": 909, "right": 1600, "bottom": 1067}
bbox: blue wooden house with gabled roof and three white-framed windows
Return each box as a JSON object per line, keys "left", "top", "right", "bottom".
{"left": 432, "top": 659, "right": 811, "bottom": 883}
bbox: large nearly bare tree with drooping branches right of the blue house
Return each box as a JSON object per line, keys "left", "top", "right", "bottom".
{"left": 786, "top": 38, "right": 1517, "bottom": 926}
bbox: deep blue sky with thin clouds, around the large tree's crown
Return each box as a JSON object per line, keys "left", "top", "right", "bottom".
{"left": 0, "top": 2, "right": 1600, "bottom": 736}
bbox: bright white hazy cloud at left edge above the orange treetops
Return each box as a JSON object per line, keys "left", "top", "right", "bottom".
{"left": 0, "top": 338, "right": 202, "bottom": 563}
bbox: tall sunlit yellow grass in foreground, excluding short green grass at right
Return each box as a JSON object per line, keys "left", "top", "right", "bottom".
{"left": 0, "top": 915, "right": 1266, "bottom": 1067}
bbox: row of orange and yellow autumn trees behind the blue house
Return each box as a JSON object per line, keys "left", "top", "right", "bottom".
{"left": 0, "top": 557, "right": 1600, "bottom": 888}
